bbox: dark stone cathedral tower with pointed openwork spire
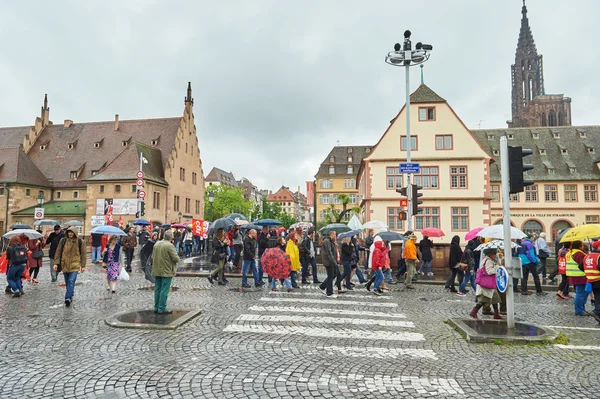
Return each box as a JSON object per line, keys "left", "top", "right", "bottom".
{"left": 507, "top": 0, "right": 571, "bottom": 127}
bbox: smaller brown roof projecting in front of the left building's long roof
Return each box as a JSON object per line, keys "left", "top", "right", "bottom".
{"left": 86, "top": 142, "right": 167, "bottom": 184}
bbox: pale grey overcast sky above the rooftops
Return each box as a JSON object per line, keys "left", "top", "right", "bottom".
{"left": 0, "top": 0, "right": 600, "bottom": 192}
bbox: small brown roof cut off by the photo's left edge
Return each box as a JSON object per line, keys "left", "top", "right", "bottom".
{"left": 0, "top": 146, "right": 52, "bottom": 187}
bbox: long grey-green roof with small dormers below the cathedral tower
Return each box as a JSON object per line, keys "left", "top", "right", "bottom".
{"left": 471, "top": 126, "right": 600, "bottom": 182}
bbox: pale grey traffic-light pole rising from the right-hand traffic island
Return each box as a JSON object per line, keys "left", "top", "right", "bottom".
{"left": 500, "top": 136, "right": 515, "bottom": 328}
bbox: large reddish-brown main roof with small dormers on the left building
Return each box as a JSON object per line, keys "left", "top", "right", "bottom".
{"left": 28, "top": 117, "right": 182, "bottom": 186}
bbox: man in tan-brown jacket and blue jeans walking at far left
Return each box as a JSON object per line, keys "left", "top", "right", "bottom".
{"left": 54, "top": 227, "right": 86, "bottom": 307}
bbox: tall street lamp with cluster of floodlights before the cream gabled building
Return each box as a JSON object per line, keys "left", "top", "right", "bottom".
{"left": 385, "top": 30, "right": 433, "bottom": 231}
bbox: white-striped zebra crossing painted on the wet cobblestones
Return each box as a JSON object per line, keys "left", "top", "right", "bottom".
{"left": 223, "top": 286, "right": 464, "bottom": 396}
